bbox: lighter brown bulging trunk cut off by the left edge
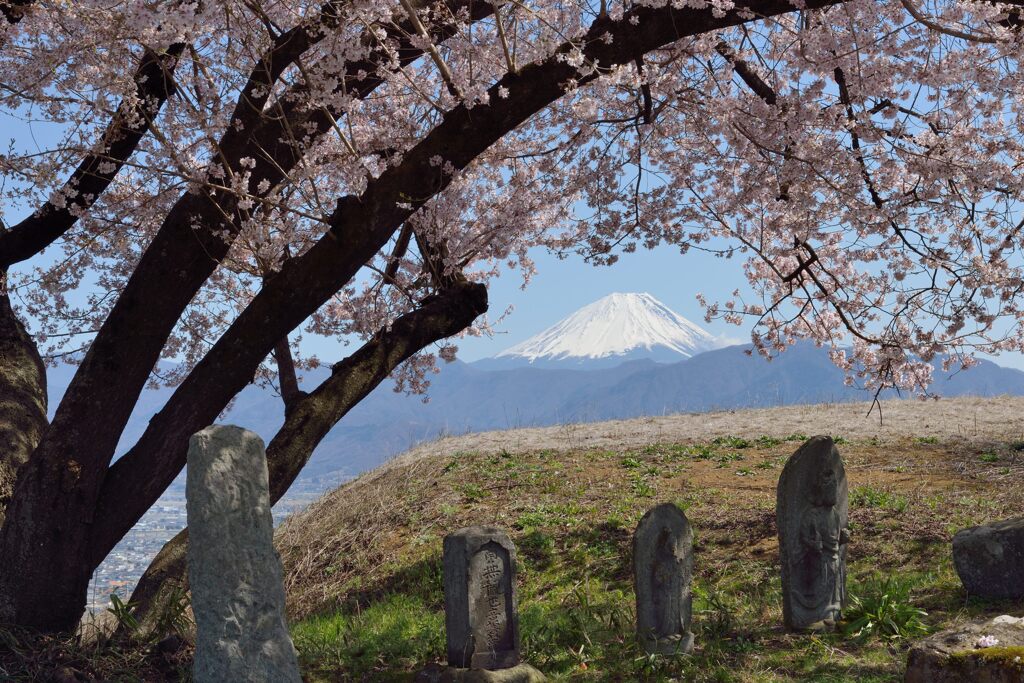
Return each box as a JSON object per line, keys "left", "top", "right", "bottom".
{"left": 0, "top": 271, "right": 47, "bottom": 524}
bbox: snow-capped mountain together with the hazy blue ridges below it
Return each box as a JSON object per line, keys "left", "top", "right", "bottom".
{"left": 39, "top": 295, "right": 1024, "bottom": 487}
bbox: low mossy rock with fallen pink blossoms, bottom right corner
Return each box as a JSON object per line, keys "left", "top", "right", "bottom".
{"left": 903, "top": 615, "right": 1024, "bottom": 683}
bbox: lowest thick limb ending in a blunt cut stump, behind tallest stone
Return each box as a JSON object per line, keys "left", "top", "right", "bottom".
{"left": 124, "top": 283, "right": 487, "bottom": 630}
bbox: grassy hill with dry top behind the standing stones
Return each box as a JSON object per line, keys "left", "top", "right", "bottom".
{"left": 276, "top": 399, "right": 1024, "bottom": 682}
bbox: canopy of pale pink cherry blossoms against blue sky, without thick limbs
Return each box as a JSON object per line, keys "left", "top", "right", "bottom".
{"left": 6, "top": 0, "right": 1024, "bottom": 392}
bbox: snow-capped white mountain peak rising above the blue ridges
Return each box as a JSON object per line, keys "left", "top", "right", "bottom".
{"left": 494, "top": 293, "right": 722, "bottom": 367}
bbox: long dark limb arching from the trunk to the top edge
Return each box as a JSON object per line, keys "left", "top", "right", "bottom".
{"left": 81, "top": 0, "right": 847, "bottom": 581}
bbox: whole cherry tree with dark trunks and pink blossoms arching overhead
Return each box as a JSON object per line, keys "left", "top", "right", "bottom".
{"left": 0, "top": 0, "right": 1024, "bottom": 631}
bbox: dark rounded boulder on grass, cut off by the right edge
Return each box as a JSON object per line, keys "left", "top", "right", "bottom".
{"left": 953, "top": 517, "right": 1024, "bottom": 599}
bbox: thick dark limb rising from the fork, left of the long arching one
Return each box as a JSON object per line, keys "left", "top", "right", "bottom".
{"left": 14, "top": 0, "right": 493, "bottom": 509}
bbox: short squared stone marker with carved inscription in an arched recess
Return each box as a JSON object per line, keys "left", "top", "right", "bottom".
{"left": 443, "top": 526, "right": 519, "bottom": 671}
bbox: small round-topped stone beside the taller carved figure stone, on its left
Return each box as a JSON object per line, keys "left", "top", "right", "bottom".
{"left": 633, "top": 503, "right": 693, "bottom": 654}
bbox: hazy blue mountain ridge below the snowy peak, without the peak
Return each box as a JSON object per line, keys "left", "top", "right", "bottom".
{"left": 299, "top": 343, "right": 1024, "bottom": 475}
